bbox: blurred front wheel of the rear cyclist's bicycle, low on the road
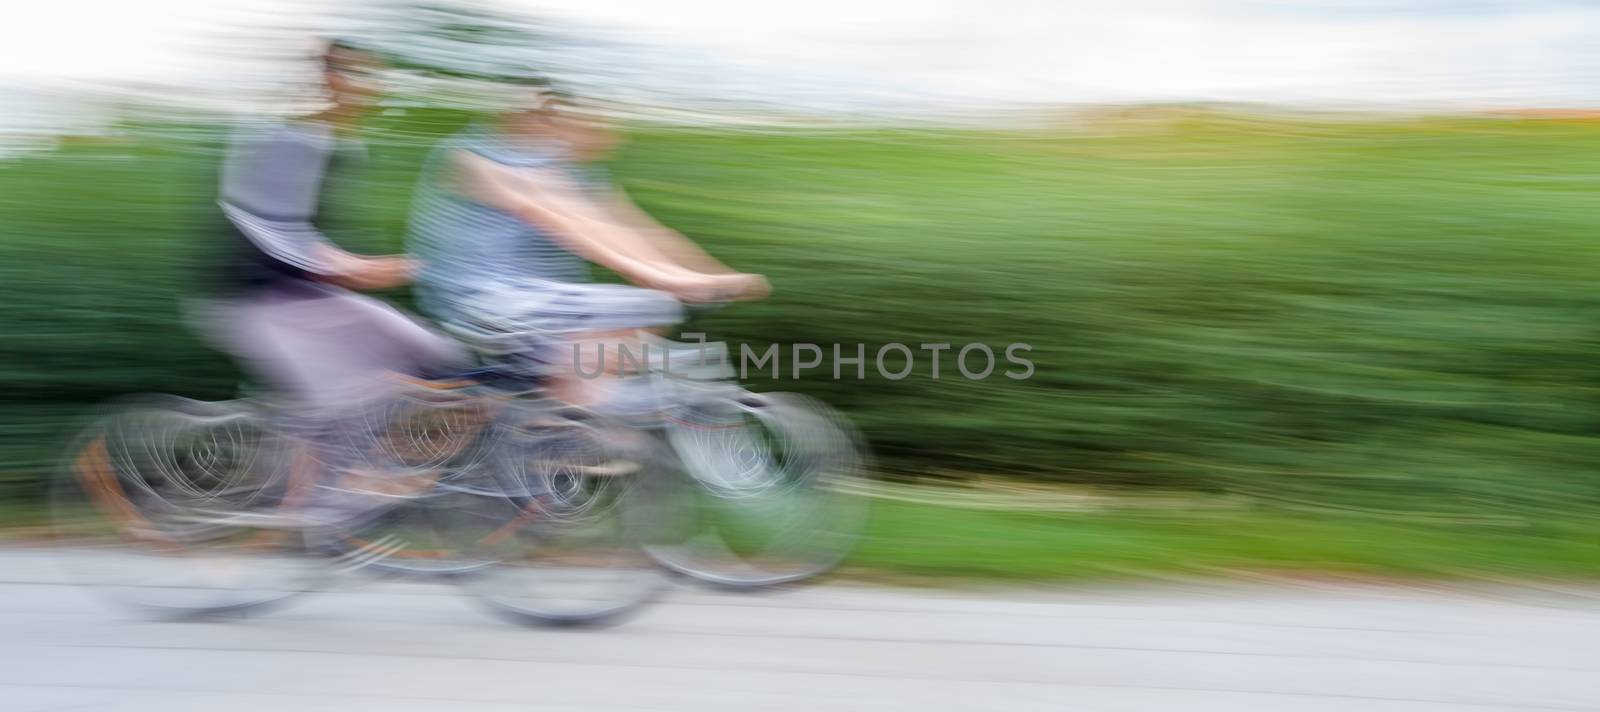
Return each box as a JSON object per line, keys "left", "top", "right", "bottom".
{"left": 457, "top": 410, "right": 666, "bottom": 626}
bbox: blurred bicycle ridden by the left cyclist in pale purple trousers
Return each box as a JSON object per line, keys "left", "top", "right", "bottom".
{"left": 53, "top": 385, "right": 664, "bottom": 624}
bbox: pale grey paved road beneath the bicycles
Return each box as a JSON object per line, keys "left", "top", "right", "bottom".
{"left": 0, "top": 550, "right": 1600, "bottom": 712}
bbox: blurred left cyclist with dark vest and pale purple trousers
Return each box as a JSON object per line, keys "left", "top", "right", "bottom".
{"left": 196, "top": 42, "right": 464, "bottom": 524}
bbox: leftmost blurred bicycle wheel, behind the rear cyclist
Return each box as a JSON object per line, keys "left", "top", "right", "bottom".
{"left": 51, "top": 397, "right": 320, "bottom": 616}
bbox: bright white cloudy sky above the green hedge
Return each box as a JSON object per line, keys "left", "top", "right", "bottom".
{"left": 0, "top": 0, "right": 1600, "bottom": 106}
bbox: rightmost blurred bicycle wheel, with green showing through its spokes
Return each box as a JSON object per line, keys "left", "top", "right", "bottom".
{"left": 646, "top": 394, "right": 869, "bottom": 589}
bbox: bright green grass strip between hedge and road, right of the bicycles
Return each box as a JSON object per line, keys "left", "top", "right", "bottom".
{"left": 845, "top": 501, "right": 1600, "bottom": 581}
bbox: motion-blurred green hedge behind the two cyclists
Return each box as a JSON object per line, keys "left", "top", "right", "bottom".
{"left": 0, "top": 109, "right": 1600, "bottom": 514}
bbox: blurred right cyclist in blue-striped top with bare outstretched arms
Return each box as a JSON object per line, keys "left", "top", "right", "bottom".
{"left": 410, "top": 85, "right": 768, "bottom": 408}
